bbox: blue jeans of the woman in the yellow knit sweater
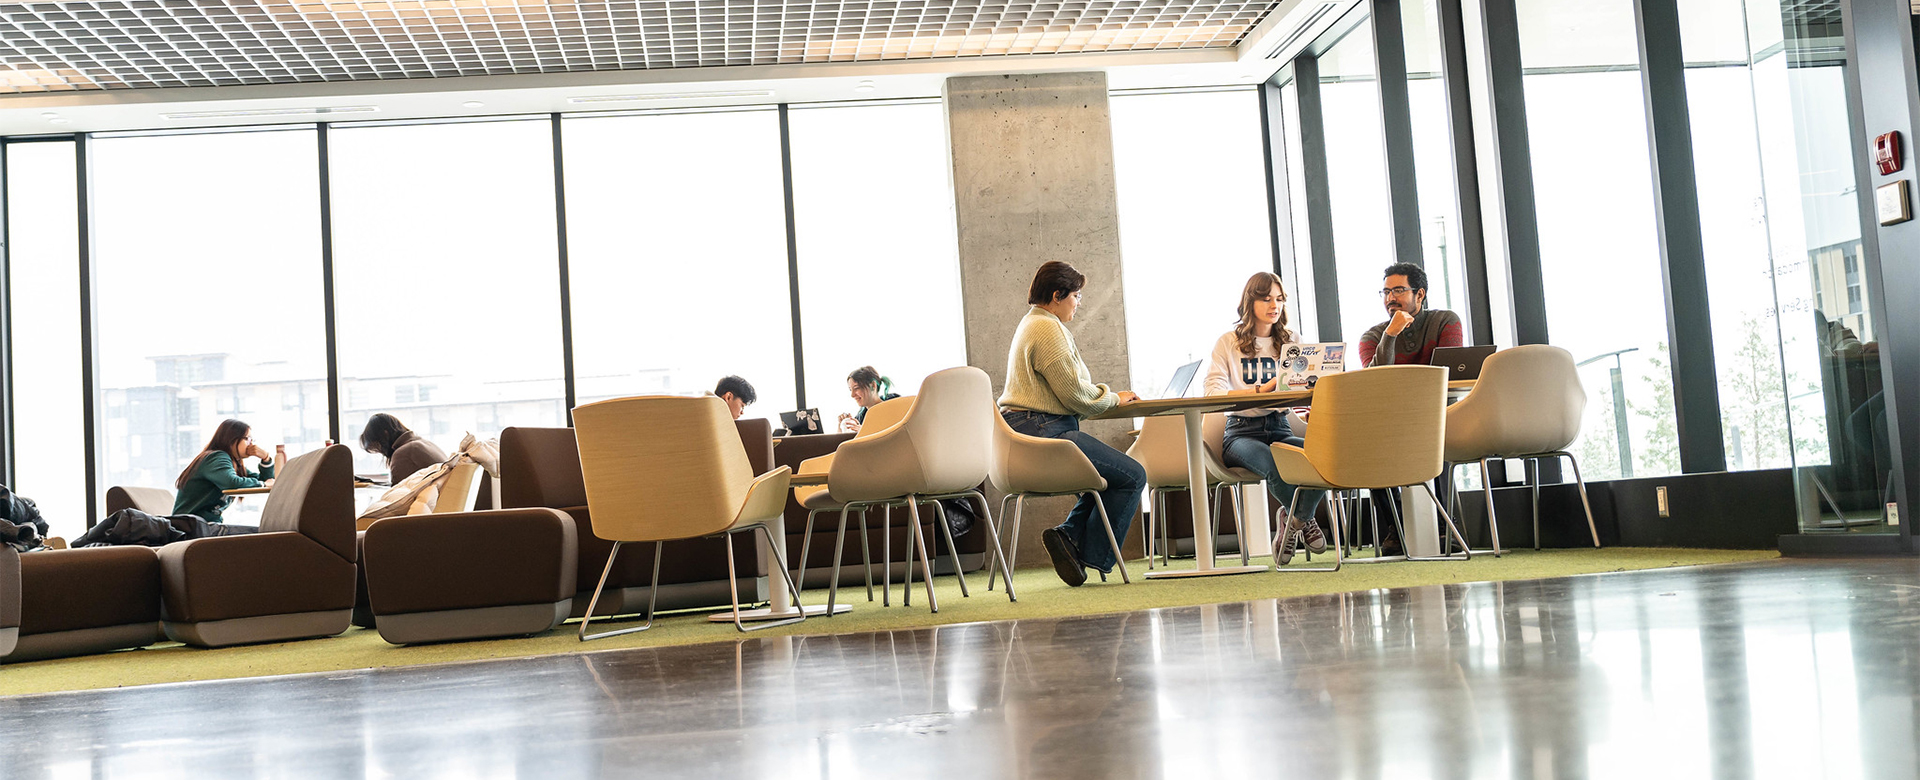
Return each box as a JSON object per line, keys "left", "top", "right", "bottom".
{"left": 1000, "top": 409, "right": 1146, "bottom": 573}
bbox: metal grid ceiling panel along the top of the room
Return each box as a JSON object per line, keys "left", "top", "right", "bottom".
{"left": 0, "top": 0, "right": 1279, "bottom": 92}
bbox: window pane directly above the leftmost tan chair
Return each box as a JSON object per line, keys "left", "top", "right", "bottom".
{"left": 563, "top": 110, "right": 795, "bottom": 417}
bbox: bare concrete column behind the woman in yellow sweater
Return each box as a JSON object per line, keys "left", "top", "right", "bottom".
{"left": 945, "top": 73, "right": 1139, "bottom": 567}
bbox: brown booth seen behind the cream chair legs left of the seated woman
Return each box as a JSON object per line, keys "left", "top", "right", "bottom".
{"left": 771, "top": 434, "right": 987, "bottom": 588}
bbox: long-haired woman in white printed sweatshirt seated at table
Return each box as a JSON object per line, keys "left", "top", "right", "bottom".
{"left": 1206, "top": 271, "right": 1327, "bottom": 565}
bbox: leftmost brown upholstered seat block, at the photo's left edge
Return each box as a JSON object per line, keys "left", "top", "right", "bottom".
{"left": 0, "top": 548, "right": 161, "bottom": 663}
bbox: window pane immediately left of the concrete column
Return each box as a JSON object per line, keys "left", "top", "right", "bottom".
{"left": 781, "top": 102, "right": 966, "bottom": 425}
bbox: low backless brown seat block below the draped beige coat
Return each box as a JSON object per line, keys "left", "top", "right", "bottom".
{"left": 361, "top": 509, "right": 580, "bottom": 644}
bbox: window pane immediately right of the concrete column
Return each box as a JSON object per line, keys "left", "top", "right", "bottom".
{"left": 1108, "top": 88, "right": 1274, "bottom": 398}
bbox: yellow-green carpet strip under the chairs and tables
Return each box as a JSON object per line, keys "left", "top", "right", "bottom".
{"left": 0, "top": 548, "right": 1778, "bottom": 695}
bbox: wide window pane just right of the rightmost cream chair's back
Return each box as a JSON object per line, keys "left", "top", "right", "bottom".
{"left": 1519, "top": 0, "right": 1680, "bottom": 478}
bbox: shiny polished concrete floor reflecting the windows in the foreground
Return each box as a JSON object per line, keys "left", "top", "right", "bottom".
{"left": 0, "top": 559, "right": 1920, "bottom": 778}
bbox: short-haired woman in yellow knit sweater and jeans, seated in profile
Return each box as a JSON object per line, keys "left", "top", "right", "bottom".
{"left": 1000, "top": 261, "right": 1146, "bottom": 586}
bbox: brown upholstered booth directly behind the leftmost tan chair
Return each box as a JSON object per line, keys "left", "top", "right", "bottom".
{"left": 499, "top": 419, "right": 774, "bottom": 617}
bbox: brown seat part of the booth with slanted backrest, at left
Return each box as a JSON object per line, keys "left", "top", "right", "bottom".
{"left": 159, "top": 530, "right": 355, "bottom": 622}
